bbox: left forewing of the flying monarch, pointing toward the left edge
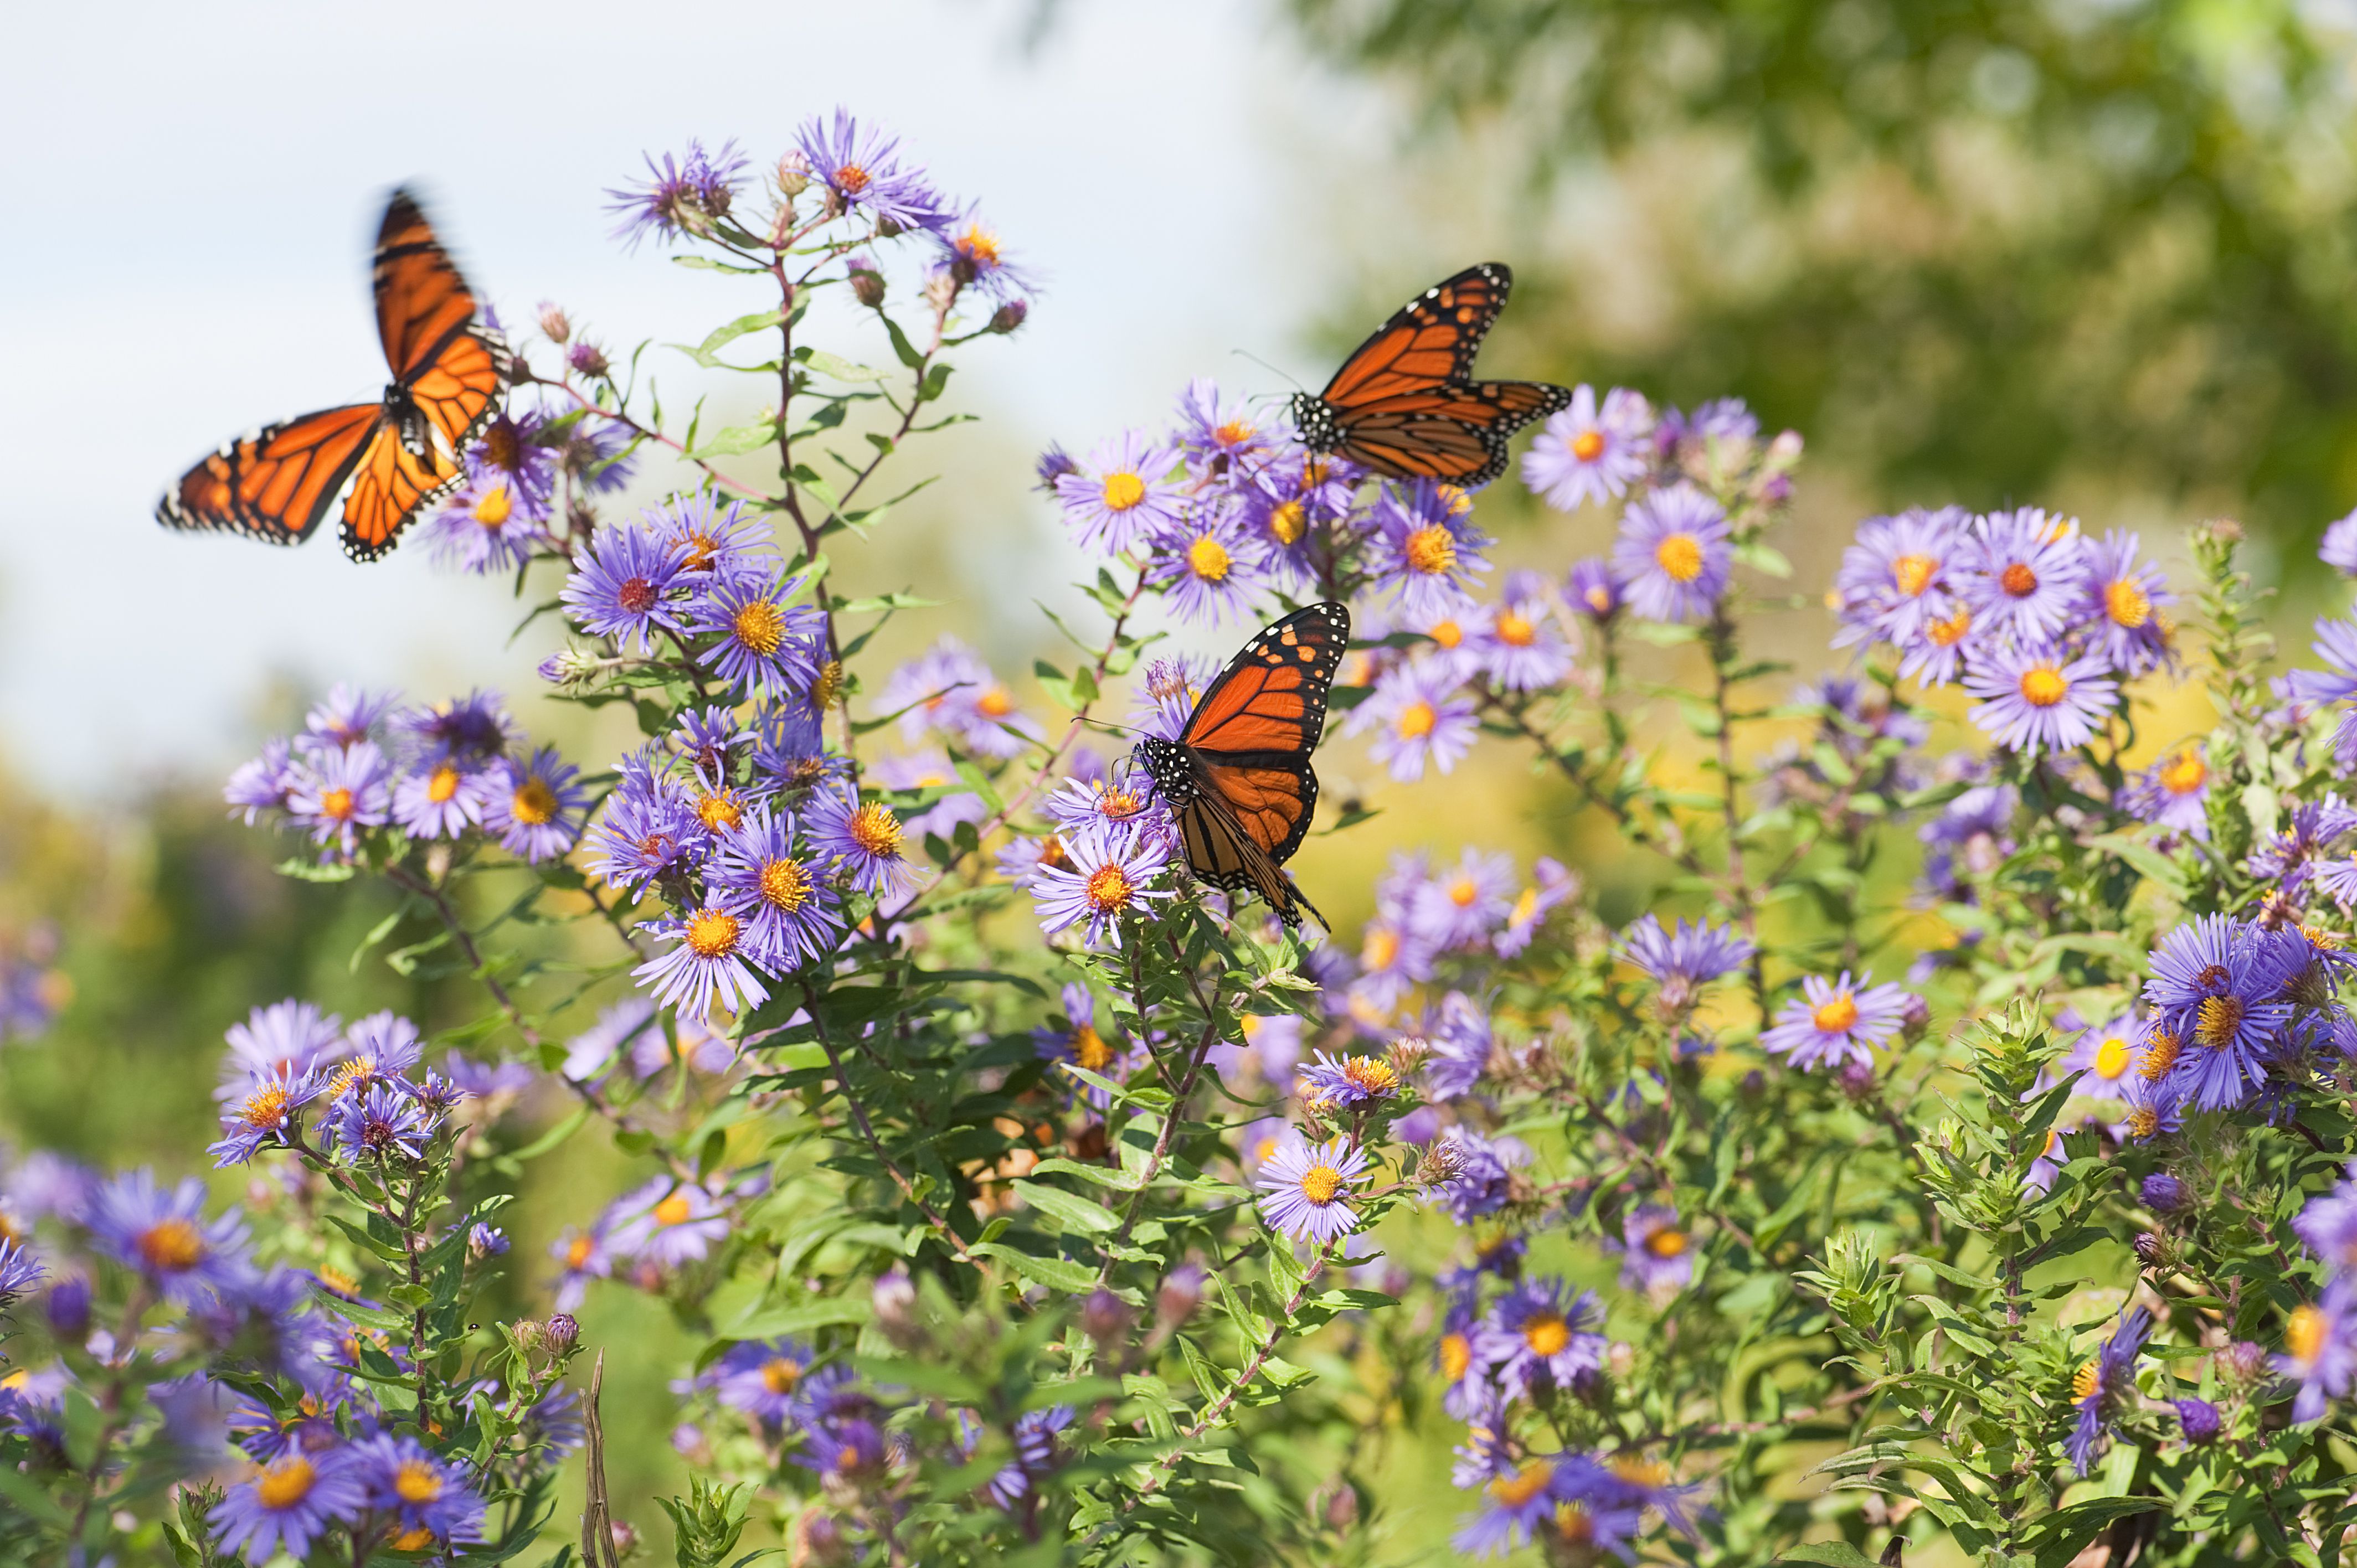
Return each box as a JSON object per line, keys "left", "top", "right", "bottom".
{"left": 156, "top": 403, "right": 389, "bottom": 545}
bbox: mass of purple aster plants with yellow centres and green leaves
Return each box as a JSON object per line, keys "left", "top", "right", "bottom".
{"left": 23, "top": 111, "right": 2357, "bottom": 1568}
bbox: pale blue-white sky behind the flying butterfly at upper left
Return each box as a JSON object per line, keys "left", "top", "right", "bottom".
{"left": 0, "top": 0, "right": 1419, "bottom": 800}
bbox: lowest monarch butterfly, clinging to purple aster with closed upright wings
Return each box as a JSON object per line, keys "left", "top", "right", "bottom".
{"left": 1136, "top": 601, "right": 1351, "bottom": 929}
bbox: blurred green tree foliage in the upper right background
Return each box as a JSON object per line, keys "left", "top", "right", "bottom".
{"left": 1287, "top": 0, "right": 2357, "bottom": 547}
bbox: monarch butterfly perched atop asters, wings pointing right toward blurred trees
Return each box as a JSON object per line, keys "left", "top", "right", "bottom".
{"left": 1291, "top": 262, "right": 1572, "bottom": 491}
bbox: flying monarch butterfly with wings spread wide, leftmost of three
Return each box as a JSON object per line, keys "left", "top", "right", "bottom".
{"left": 156, "top": 191, "right": 512, "bottom": 561}
